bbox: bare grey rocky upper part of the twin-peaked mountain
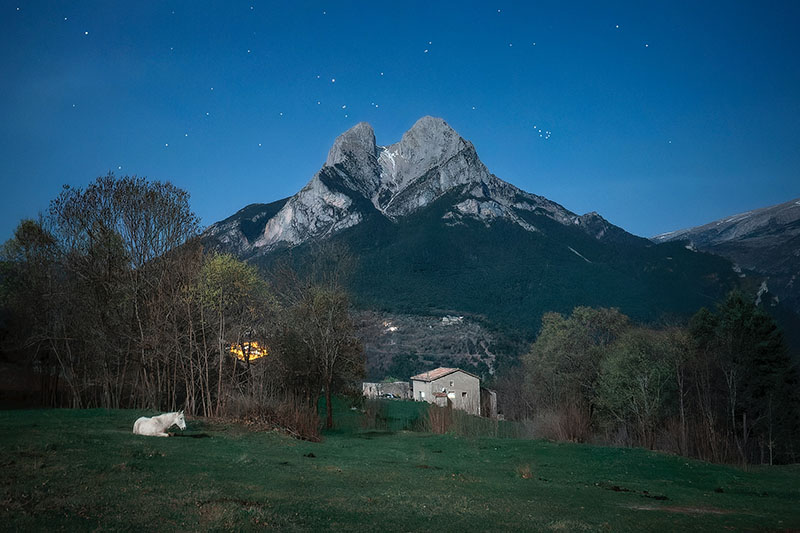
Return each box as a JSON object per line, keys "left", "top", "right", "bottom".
{"left": 207, "top": 117, "right": 636, "bottom": 256}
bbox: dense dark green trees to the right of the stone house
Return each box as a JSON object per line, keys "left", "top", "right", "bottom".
{"left": 498, "top": 298, "right": 800, "bottom": 464}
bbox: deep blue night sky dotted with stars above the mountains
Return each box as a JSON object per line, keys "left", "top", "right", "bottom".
{"left": 0, "top": 0, "right": 800, "bottom": 241}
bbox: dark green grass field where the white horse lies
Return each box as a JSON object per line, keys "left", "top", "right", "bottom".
{"left": 0, "top": 402, "right": 800, "bottom": 531}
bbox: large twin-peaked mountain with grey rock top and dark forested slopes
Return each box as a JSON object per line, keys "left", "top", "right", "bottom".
{"left": 204, "top": 117, "right": 738, "bottom": 377}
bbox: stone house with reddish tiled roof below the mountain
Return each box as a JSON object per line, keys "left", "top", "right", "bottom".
{"left": 411, "top": 367, "right": 481, "bottom": 415}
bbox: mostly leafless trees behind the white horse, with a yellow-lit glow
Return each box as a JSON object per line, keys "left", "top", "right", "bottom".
{"left": 0, "top": 174, "right": 364, "bottom": 437}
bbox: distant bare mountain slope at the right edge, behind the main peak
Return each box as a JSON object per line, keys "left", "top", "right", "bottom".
{"left": 652, "top": 198, "right": 800, "bottom": 313}
